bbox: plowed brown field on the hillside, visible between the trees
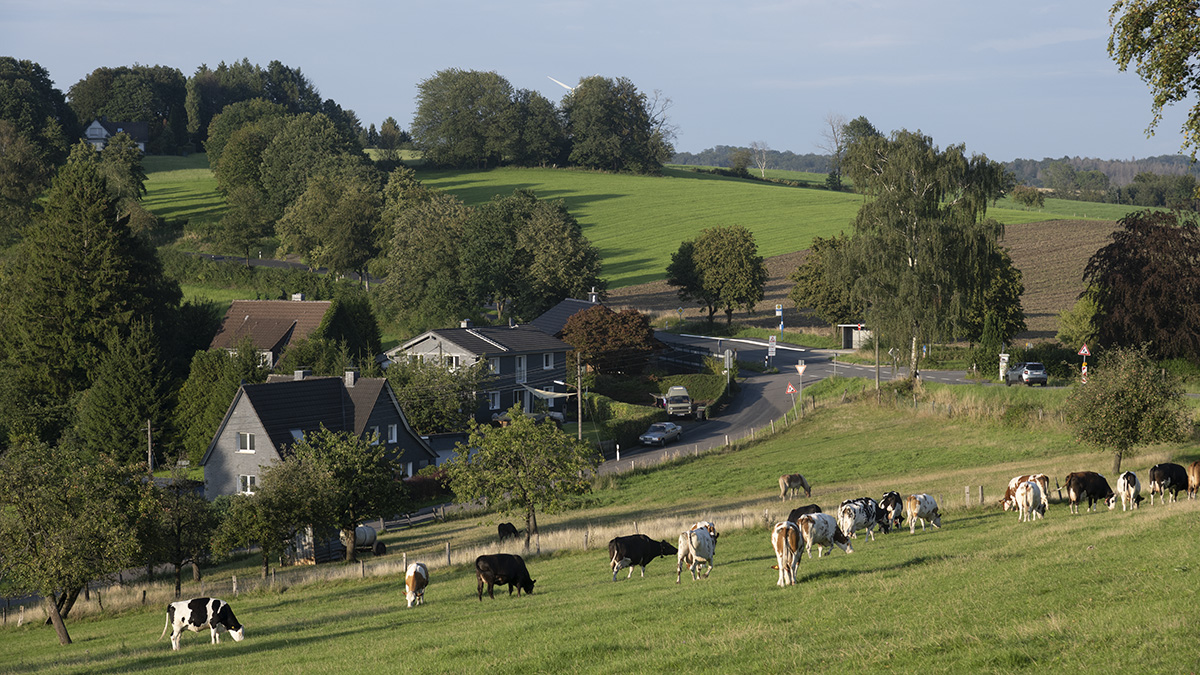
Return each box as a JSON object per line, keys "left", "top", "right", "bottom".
{"left": 608, "top": 220, "right": 1117, "bottom": 340}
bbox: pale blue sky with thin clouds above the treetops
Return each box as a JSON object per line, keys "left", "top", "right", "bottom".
{"left": 0, "top": 0, "right": 1186, "bottom": 161}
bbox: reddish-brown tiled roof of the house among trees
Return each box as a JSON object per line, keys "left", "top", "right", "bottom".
{"left": 209, "top": 300, "right": 332, "bottom": 351}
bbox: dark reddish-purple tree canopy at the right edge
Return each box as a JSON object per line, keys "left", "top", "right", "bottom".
{"left": 1084, "top": 211, "right": 1200, "bottom": 360}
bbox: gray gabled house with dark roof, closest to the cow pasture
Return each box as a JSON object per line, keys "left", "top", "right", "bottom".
{"left": 200, "top": 371, "right": 437, "bottom": 500}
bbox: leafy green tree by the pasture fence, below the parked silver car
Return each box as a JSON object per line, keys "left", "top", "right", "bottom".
{"left": 444, "top": 405, "right": 601, "bottom": 549}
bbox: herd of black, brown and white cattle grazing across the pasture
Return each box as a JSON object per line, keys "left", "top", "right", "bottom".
{"left": 158, "top": 461, "right": 1200, "bottom": 650}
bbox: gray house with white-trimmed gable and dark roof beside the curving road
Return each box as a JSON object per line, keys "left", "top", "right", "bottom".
{"left": 386, "top": 324, "right": 574, "bottom": 422}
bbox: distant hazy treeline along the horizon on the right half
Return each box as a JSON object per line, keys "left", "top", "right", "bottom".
{"left": 671, "top": 145, "right": 1200, "bottom": 187}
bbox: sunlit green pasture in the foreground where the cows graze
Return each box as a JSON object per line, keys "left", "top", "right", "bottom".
{"left": 0, "top": 388, "right": 1200, "bottom": 673}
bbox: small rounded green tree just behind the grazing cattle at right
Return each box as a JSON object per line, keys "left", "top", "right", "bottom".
{"left": 1066, "top": 347, "right": 1190, "bottom": 476}
